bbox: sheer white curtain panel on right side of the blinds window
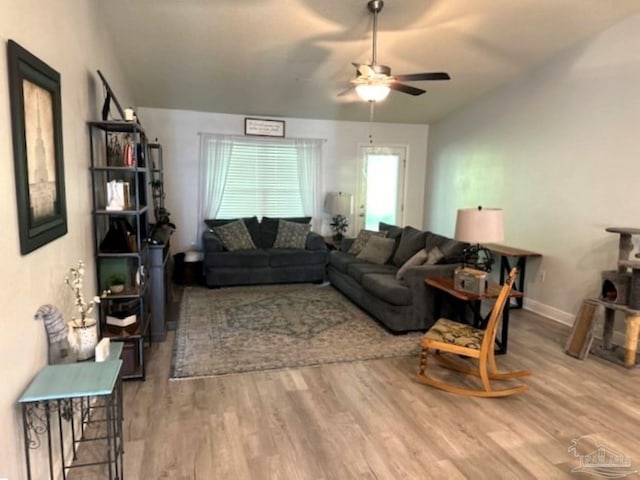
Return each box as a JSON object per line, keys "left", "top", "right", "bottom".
{"left": 295, "top": 138, "right": 323, "bottom": 231}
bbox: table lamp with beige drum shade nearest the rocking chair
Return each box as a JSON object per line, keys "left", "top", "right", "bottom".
{"left": 454, "top": 206, "right": 504, "bottom": 272}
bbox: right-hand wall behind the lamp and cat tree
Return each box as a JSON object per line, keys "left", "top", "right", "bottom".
{"left": 426, "top": 16, "right": 640, "bottom": 322}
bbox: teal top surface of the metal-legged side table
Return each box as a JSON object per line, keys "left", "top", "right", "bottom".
{"left": 18, "top": 342, "right": 122, "bottom": 403}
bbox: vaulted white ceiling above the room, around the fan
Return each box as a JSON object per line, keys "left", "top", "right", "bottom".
{"left": 96, "top": 0, "right": 640, "bottom": 123}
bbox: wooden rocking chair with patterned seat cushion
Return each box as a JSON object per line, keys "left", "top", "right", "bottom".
{"left": 418, "top": 268, "right": 531, "bottom": 397}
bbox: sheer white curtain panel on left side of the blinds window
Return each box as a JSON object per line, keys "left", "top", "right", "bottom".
{"left": 196, "top": 133, "right": 233, "bottom": 246}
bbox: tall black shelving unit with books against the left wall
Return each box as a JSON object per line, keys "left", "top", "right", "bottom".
{"left": 89, "top": 121, "right": 152, "bottom": 380}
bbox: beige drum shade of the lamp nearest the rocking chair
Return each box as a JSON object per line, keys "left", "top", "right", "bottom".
{"left": 455, "top": 208, "right": 504, "bottom": 244}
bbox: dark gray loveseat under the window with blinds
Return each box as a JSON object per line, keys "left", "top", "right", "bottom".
{"left": 203, "top": 217, "right": 328, "bottom": 287}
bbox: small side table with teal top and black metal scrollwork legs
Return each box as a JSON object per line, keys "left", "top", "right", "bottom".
{"left": 18, "top": 342, "right": 124, "bottom": 480}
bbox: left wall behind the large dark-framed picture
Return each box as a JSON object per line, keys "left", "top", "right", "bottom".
{"left": 0, "top": 0, "right": 128, "bottom": 480}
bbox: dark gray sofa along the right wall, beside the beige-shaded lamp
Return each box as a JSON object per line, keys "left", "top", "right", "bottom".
{"left": 327, "top": 224, "right": 467, "bottom": 332}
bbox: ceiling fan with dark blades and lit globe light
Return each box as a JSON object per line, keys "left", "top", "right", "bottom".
{"left": 338, "top": 0, "right": 451, "bottom": 102}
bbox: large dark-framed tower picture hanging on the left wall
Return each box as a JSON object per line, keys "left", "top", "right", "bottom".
{"left": 7, "top": 40, "right": 67, "bottom": 255}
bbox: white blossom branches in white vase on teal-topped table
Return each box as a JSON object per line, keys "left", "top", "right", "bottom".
{"left": 64, "top": 260, "right": 106, "bottom": 360}
